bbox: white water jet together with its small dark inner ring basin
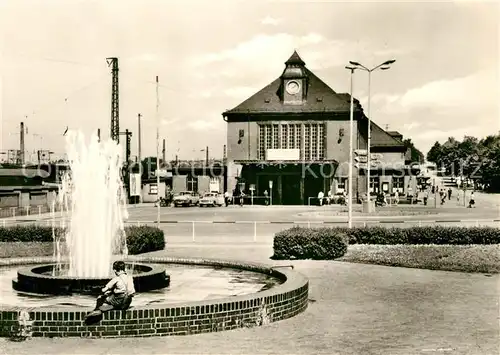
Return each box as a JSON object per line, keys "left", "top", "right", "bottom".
{"left": 13, "top": 132, "right": 170, "bottom": 294}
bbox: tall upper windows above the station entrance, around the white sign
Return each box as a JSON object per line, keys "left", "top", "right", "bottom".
{"left": 259, "top": 123, "right": 325, "bottom": 160}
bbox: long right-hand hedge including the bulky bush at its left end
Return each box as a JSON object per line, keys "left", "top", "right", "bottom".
{"left": 272, "top": 226, "right": 500, "bottom": 260}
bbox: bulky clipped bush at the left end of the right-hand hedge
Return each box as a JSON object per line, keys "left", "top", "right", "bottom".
{"left": 272, "top": 227, "right": 348, "bottom": 260}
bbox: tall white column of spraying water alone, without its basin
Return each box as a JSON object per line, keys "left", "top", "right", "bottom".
{"left": 59, "top": 132, "right": 128, "bottom": 277}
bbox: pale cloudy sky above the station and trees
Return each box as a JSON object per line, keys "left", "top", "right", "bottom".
{"left": 0, "top": 0, "right": 500, "bottom": 163}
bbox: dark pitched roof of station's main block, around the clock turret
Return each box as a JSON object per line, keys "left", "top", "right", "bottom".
{"left": 223, "top": 65, "right": 360, "bottom": 115}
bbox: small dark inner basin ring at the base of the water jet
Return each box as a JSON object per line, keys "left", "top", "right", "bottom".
{"left": 12, "top": 263, "right": 170, "bottom": 295}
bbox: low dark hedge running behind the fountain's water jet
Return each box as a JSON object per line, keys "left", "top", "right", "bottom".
{"left": 0, "top": 225, "right": 165, "bottom": 255}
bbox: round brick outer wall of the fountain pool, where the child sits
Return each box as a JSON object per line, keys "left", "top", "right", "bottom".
{"left": 0, "top": 256, "right": 309, "bottom": 337}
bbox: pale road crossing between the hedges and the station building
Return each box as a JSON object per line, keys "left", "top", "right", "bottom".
{"left": 3, "top": 203, "right": 500, "bottom": 245}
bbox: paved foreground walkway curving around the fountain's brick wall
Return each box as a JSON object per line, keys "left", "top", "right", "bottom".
{"left": 0, "top": 246, "right": 500, "bottom": 355}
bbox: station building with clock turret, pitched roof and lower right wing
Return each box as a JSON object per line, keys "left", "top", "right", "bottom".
{"left": 223, "top": 52, "right": 415, "bottom": 204}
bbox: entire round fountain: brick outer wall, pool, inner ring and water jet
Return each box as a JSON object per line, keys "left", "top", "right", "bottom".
{"left": 0, "top": 133, "right": 309, "bottom": 337}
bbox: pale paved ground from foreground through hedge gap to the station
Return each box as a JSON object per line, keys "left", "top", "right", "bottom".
{"left": 0, "top": 196, "right": 500, "bottom": 355}
